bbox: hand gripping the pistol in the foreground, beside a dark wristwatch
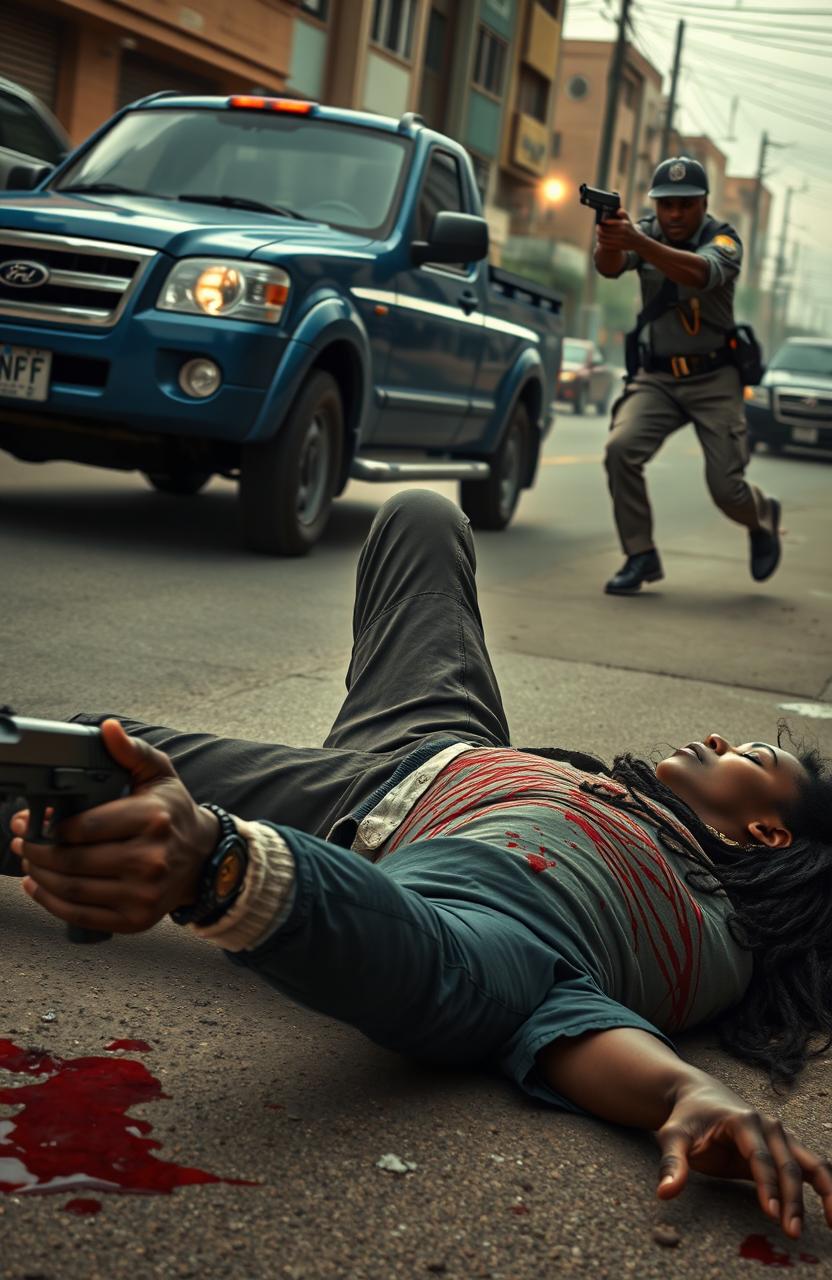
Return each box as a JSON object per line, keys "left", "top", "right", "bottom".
{"left": 12, "top": 719, "right": 218, "bottom": 933}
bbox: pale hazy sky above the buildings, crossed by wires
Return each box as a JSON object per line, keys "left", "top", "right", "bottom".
{"left": 564, "top": 0, "right": 832, "bottom": 334}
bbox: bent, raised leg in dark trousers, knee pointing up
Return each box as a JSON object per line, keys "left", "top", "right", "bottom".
{"left": 325, "top": 489, "right": 509, "bottom": 751}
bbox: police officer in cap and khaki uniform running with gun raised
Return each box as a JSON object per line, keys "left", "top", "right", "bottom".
{"left": 595, "top": 156, "right": 780, "bottom": 595}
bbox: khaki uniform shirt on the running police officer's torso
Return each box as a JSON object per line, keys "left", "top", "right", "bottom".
{"left": 620, "top": 214, "right": 742, "bottom": 356}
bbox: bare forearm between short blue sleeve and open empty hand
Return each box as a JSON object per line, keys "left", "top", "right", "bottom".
{"left": 538, "top": 1027, "right": 710, "bottom": 1129}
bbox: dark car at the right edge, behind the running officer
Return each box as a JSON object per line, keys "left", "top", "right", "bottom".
{"left": 745, "top": 338, "right": 832, "bottom": 453}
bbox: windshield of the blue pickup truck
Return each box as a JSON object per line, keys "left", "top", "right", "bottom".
{"left": 52, "top": 108, "right": 408, "bottom": 236}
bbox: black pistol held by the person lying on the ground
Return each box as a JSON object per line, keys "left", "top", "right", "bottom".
{"left": 0, "top": 712, "right": 131, "bottom": 942}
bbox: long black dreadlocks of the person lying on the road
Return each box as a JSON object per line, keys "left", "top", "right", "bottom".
{"left": 530, "top": 724, "right": 832, "bottom": 1087}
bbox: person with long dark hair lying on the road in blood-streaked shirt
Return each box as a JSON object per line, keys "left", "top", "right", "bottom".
{"left": 0, "top": 492, "right": 832, "bottom": 1238}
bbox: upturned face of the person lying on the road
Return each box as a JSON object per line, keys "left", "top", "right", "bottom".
{"left": 655, "top": 733, "right": 806, "bottom": 847}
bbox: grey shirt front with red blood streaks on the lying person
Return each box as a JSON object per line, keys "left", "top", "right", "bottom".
{"left": 380, "top": 749, "right": 716, "bottom": 1030}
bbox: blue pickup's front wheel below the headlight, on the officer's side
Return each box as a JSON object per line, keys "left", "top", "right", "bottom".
{"left": 239, "top": 370, "right": 344, "bottom": 556}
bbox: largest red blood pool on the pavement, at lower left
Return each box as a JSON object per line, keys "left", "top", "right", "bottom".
{"left": 0, "top": 1039, "right": 257, "bottom": 1212}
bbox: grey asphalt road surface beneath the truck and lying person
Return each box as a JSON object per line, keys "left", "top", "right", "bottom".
{"left": 0, "top": 410, "right": 832, "bottom": 1280}
